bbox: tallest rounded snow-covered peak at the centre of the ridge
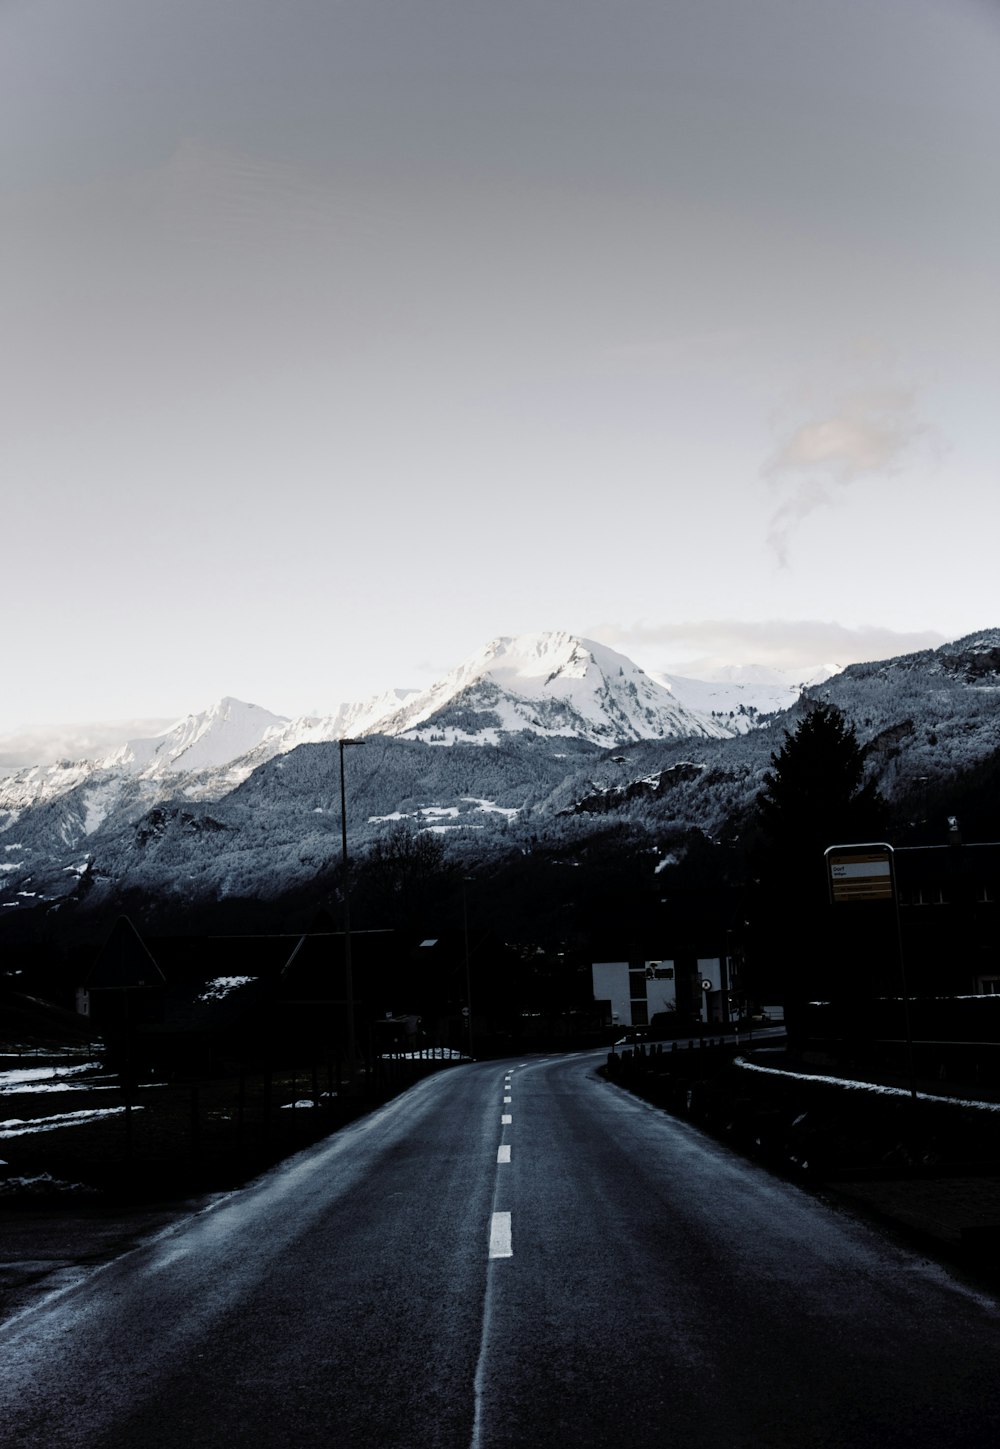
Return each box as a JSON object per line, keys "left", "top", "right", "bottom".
{"left": 369, "top": 632, "right": 733, "bottom": 745}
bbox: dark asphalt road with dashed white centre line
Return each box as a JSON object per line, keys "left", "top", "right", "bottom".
{"left": 0, "top": 1055, "right": 1000, "bottom": 1449}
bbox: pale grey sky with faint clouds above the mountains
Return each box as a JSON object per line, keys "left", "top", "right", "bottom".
{"left": 0, "top": 0, "right": 1000, "bottom": 733}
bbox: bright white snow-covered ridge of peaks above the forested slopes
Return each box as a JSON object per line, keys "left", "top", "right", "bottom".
{"left": 0, "top": 633, "right": 724, "bottom": 846}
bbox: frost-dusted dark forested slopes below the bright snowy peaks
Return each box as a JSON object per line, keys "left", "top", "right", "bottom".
{"left": 0, "top": 630, "right": 1000, "bottom": 936}
